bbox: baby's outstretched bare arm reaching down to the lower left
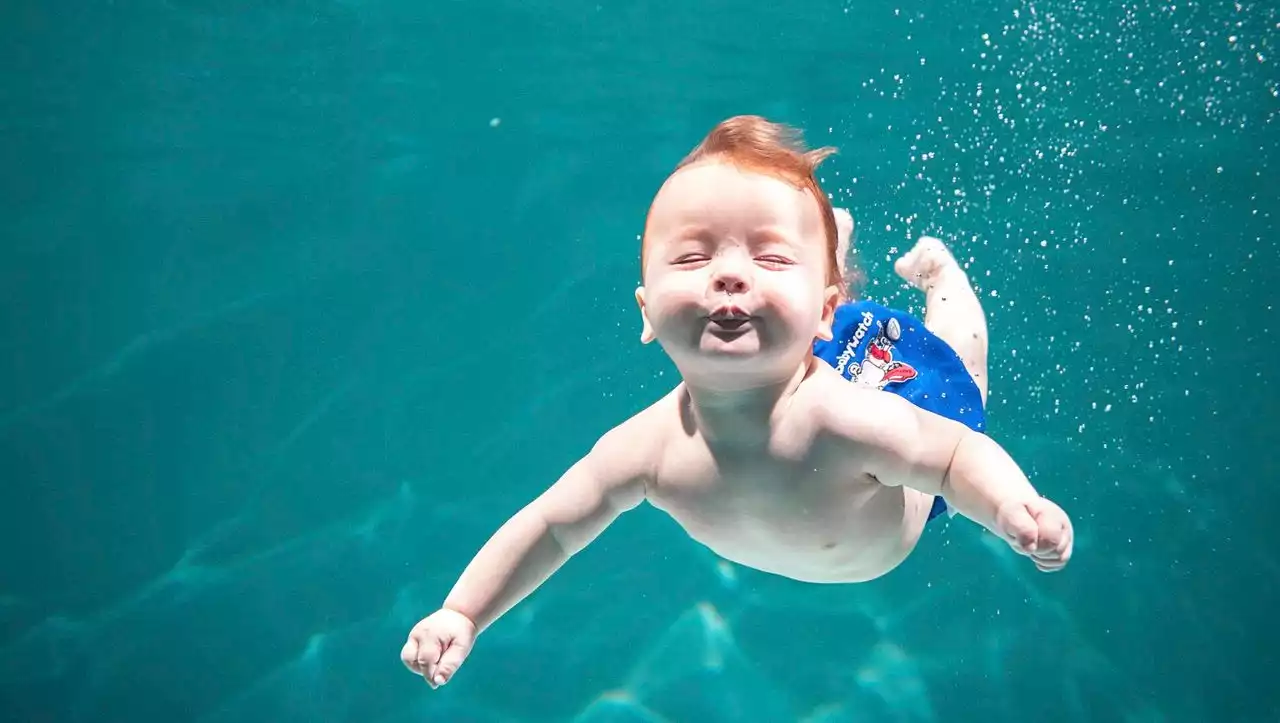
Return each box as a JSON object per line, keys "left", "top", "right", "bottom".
{"left": 401, "top": 420, "right": 654, "bottom": 687}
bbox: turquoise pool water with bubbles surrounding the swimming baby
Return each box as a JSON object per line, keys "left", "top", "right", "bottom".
{"left": 0, "top": 0, "right": 1280, "bottom": 723}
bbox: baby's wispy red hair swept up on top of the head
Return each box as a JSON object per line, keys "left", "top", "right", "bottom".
{"left": 641, "top": 115, "right": 844, "bottom": 287}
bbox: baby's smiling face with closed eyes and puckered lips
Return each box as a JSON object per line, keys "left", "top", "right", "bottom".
{"left": 636, "top": 163, "right": 838, "bottom": 381}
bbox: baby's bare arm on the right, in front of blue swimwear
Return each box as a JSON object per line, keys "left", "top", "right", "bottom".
{"left": 826, "top": 384, "right": 1073, "bottom": 571}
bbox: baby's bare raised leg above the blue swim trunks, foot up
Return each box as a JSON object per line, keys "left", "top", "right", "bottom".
{"left": 893, "top": 235, "right": 987, "bottom": 406}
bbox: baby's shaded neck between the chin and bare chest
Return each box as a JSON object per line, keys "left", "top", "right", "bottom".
{"left": 685, "top": 357, "right": 815, "bottom": 445}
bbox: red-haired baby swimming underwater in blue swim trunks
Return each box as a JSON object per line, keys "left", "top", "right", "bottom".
{"left": 401, "top": 116, "right": 1073, "bottom": 687}
